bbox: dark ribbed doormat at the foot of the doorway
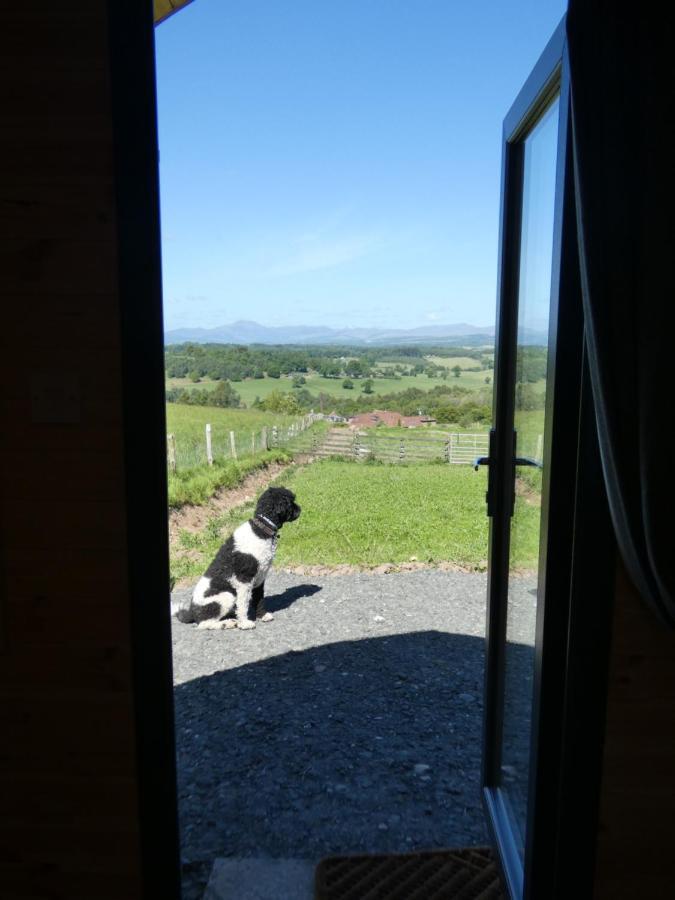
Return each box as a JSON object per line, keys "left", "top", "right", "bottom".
{"left": 314, "top": 847, "right": 507, "bottom": 900}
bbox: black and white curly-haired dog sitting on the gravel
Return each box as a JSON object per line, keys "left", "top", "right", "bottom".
{"left": 176, "top": 488, "right": 300, "bottom": 628}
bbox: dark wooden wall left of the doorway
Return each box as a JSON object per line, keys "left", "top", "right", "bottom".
{"left": 0, "top": 0, "right": 141, "bottom": 900}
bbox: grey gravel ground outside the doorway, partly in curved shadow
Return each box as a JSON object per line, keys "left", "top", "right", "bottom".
{"left": 173, "top": 570, "right": 508, "bottom": 884}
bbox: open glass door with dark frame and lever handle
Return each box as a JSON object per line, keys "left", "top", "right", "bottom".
{"left": 477, "top": 21, "right": 583, "bottom": 898}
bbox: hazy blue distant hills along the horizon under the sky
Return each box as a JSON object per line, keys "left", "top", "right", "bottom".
{"left": 164, "top": 320, "right": 546, "bottom": 347}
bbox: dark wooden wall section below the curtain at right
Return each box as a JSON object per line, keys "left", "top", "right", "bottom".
{"left": 594, "top": 570, "right": 675, "bottom": 900}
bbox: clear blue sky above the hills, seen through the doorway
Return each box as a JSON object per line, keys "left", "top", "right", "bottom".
{"left": 156, "top": 0, "right": 565, "bottom": 329}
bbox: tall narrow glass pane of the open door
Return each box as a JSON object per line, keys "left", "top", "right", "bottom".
{"left": 501, "top": 99, "right": 559, "bottom": 859}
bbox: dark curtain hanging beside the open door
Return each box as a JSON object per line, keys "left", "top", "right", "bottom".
{"left": 567, "top": 0, "right": 675, "bottom": 628}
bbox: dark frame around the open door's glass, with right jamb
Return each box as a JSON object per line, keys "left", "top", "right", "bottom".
{"left": 482, "top": 19, "right": 615, "bottom": 900}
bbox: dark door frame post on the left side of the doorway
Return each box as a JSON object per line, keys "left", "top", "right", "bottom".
{"left": 107, "top": 0, "right": 181, "bottom": 900}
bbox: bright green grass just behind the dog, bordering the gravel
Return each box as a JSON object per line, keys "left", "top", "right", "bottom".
{"left": 172, "top": 460, "right": 539, "bottom": 579}
